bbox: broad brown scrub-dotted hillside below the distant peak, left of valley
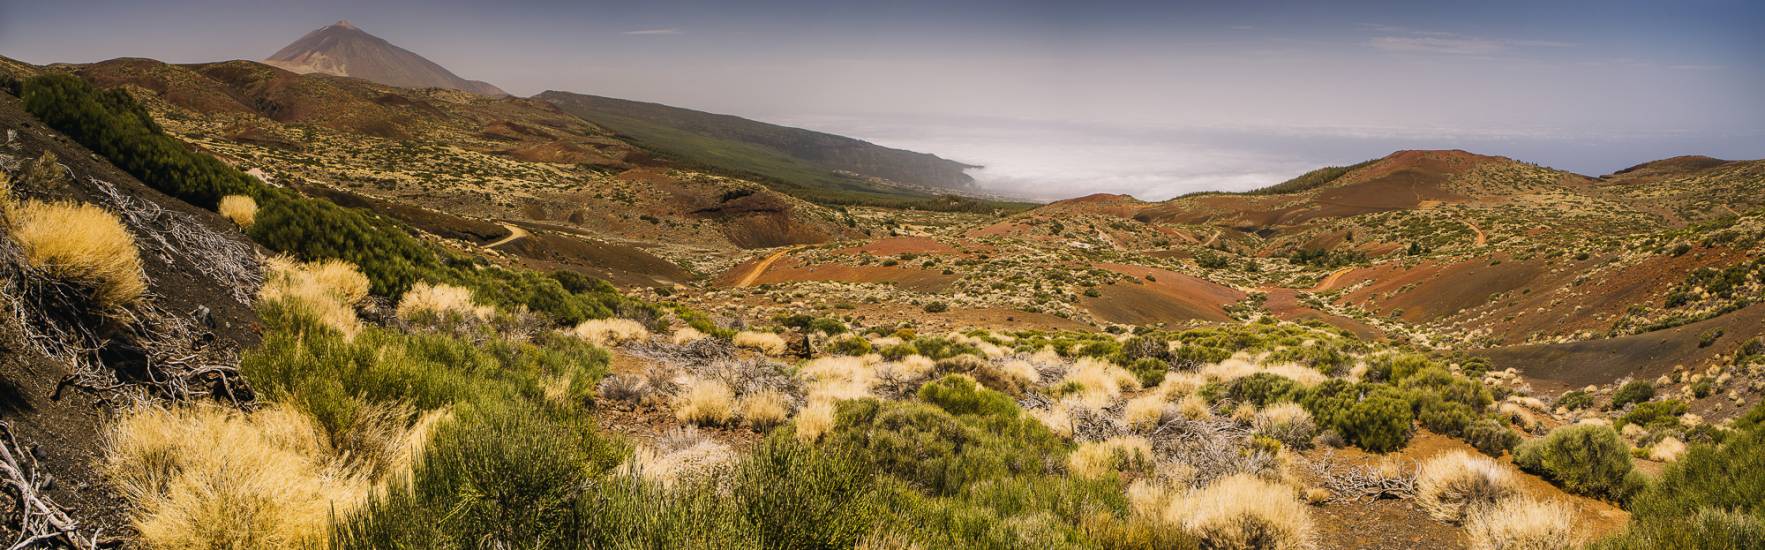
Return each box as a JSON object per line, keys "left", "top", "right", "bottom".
{"left": 10, "top": 58, "right": 861, "bottom": 278}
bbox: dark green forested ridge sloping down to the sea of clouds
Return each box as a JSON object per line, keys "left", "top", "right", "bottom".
{"left": 537, "top": 92, "right": 974, "bottom": 199}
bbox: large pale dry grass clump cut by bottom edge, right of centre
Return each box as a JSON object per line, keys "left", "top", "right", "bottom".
{"left": 1165, "top": 474, "right": 1313, "bottom": 548}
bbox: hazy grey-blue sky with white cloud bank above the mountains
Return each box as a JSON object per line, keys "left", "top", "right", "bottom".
{"left": 0, "top": 0, "right": 1765, "bottom": 199}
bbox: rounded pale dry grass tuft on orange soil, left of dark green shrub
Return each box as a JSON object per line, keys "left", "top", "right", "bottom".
{"left": 1416, "top": 451, "right": 1520, "bottom": 524}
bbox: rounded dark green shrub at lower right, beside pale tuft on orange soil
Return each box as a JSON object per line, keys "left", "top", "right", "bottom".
{"left": 1514, "top": 425, "right": 1641, "bottom": 502}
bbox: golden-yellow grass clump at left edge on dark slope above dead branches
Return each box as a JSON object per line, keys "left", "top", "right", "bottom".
{"left": 5, "top": 199, "right": 146, "bottom": 308}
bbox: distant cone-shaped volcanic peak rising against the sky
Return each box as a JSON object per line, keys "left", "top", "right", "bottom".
{"left": 263, "top": 21, "right": 508, "bottom": 95}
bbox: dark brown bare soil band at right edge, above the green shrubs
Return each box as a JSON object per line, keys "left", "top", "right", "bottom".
{"left": 1477, "top": 303, "right": 1765, "bottom": 391}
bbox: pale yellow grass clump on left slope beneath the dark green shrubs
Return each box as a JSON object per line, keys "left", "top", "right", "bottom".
{"left": 258, "top": 256, "right": 367, "bottom": 338}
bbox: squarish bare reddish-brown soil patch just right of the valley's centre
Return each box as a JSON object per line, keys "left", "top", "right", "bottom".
{"left": 1080, "top": 263, "right": 1244, "bottom": 324}
